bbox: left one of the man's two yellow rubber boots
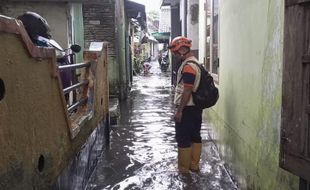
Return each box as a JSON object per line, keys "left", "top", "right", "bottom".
{"left": 178, "top": 147, "right": 192, "bottom": 173}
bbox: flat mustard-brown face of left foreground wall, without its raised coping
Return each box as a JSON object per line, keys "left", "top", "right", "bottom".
{"left": 0, "top": 28, "right": 72, "bottom": 189}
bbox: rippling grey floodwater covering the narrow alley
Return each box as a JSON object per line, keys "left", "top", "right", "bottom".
{"left": 86, "top": 62, "right": 237, "bottom": 190}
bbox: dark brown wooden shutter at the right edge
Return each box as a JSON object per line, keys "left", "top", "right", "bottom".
{"left": 280, "top": 0, "right": 310, "bottom": 180}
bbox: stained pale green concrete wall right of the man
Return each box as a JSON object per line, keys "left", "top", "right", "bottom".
{"left": 205, "top": 0, "right": 298, "bottom": 190}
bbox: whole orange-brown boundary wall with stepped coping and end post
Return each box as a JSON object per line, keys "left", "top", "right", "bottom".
{"left": 0, "top": 17, "right": 108, "bottom": 190}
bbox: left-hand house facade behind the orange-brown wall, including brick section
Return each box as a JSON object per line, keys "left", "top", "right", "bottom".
{"left": 0, "top": 0, "right": 146, "bottom": 99}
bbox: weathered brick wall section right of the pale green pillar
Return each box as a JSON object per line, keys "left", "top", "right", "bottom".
{"left": 83, "top": 3, "right": 116, "bottom": 57}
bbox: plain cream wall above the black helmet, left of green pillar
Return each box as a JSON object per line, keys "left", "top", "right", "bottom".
{"left": 0, "top": 2, "right": 69, "bottom": 48}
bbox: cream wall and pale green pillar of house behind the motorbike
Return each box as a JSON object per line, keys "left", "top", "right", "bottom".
{"left": 0, "top": 0, "right": 84, "bottom": 62}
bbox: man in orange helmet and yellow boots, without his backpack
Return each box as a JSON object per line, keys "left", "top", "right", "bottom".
{"left": 168, "top": 36, "right": 202, "bottom": 173}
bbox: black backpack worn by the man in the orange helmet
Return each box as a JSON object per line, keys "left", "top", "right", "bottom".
{"left": 185, "top": 61, "right": 219, "bottom": 109}
